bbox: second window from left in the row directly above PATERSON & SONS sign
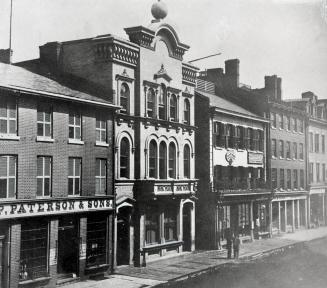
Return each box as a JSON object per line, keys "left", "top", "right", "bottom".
{"left": 36, "top": 156, "right": 52, "bottom": 197}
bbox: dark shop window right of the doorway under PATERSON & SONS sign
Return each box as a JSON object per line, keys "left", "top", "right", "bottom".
{"left": 86, "top": 214, "right": 107, "bottom": 266}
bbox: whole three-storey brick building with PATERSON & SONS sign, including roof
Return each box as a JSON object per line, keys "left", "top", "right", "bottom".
{"left": 0, "top": 63, "right": 117, "bottom": 287}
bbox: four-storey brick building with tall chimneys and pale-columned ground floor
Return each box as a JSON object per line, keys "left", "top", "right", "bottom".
{"left": 200, "top": 59, "right": 308, "bottom": 233}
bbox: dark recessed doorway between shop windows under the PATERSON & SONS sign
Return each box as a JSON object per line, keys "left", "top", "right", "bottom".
{"left": 57, "top": 217, "right": 79, "bottom": 277}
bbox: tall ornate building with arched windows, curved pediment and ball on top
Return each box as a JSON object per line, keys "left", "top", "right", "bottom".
{"left": 25, "top": 2, "right": 197, "bottom": 265}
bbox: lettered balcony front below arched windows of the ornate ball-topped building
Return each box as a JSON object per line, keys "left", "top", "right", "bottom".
{"left": 137, "top": 179, "right": 197, "bottom": 196}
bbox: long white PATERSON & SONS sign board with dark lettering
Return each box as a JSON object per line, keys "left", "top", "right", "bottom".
{"left": 0, "top": 196, "right": 113, "bottom": 219}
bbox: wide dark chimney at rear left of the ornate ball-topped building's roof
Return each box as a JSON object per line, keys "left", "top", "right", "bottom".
{"left": 39, "top": 42, "right": 62, "bottom": 71}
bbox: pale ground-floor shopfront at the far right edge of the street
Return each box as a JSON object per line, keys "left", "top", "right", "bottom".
{"left": 308, "top": 187, "right": 326, "bottom": 228}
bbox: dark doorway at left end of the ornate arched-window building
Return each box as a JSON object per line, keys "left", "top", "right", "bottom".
{"left": 117, "top": 207, "right": 131, "bottom": 265}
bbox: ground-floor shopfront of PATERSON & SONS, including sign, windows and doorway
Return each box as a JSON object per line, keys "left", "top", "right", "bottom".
{"left": 0, "top": 197, "right": 114, "bottom": 288}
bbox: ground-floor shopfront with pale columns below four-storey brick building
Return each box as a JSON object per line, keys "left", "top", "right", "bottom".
{"left": 272, "top": 191, "right": 308, "bottom": 234}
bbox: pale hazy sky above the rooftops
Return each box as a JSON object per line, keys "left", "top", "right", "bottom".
{"left": 0, "top": 0, "right": 327, "bottom": 99}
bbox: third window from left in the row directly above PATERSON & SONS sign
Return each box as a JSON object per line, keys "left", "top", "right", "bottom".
{"left": 68, "top": 158, "right": 82, "bottom": 195}
